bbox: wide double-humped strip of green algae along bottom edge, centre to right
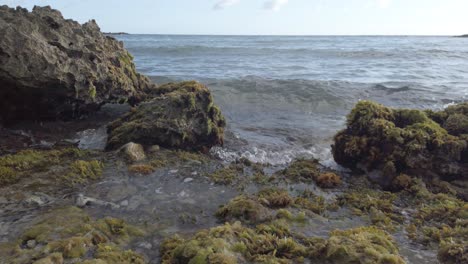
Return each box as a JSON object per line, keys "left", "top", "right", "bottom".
{"left": 160, "top": 220, "right": 405, "bottom": 264}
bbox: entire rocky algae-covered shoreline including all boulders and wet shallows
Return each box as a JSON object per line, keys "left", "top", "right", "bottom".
{"left": 0, "top": 6, "right": 468, "bottom": 264}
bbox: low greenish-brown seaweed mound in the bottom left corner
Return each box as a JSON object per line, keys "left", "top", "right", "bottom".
{"left": 0, "top": 207, "right": 146, "bottom": 263}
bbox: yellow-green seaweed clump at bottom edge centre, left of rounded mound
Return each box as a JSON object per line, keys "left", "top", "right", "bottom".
{"left": 161, "top": 222, "right": 306, "bottom": 264}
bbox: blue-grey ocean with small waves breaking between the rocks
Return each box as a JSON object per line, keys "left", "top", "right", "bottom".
{"left": 115, "top": 35, "right": 468, "bottom": 166}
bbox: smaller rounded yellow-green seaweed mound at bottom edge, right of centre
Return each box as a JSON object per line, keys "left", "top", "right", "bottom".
{"left": 310, "top": 227, "right": 405, "bottom": 264}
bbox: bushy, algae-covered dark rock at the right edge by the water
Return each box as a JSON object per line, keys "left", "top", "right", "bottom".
{"left": 332, "top": 101, "right": 468, "bottom": 187}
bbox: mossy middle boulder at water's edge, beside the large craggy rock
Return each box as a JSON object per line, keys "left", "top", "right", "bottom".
{"left": 106, "top": 81, "right": 226, "bottom": 151}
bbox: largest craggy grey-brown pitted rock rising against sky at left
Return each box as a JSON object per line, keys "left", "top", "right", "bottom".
{"left": 0, "top": 6, "right": 155, "bottom": 121}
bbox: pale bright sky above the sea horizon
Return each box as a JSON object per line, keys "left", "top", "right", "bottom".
{"left": 0, "top": 0, "right": 468, "bottom": 35}
